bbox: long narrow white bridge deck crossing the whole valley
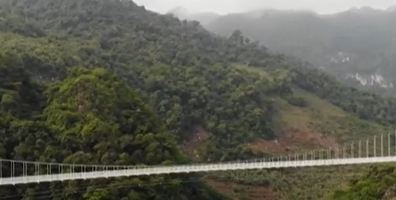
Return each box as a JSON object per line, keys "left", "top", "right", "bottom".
{"left": 0, "top": 156, "right": 396, "bottom": 185}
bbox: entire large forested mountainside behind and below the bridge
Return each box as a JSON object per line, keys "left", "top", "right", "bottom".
{"left": 0, "top": 0, "right": 396, "bottom": 200}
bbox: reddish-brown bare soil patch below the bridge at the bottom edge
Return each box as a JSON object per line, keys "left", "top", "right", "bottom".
{"left": 205, "top": 179, "right": 283, "bottom": 200}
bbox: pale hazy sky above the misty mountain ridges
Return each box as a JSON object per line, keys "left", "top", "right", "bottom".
{"left": 133, "top": 0, "right": 396, "bottom": 14}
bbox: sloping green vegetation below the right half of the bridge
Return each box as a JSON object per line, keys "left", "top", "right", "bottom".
{"left": 210, "top": 166, "right": 367, "bottom": 199}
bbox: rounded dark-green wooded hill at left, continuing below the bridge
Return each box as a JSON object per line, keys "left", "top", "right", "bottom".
{"left": 0, "top": 61, "right": 229, "bottom": 200}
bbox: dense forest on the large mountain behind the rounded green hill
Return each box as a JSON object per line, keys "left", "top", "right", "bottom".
{"left": 1, "top": 0, "right": 289, "bottom": 160}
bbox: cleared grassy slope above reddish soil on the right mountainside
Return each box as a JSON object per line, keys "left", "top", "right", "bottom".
{"left": 275, "top": 88, "right": 387, "bottom": 143}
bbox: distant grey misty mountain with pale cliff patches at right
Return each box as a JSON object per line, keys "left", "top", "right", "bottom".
{"left": 183, "top": 7, "right": 396, "bottom": 94}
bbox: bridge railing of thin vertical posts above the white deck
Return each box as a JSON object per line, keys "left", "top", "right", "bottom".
{"left": 0, "top": 132, "right": 396, "bottom": 181}
